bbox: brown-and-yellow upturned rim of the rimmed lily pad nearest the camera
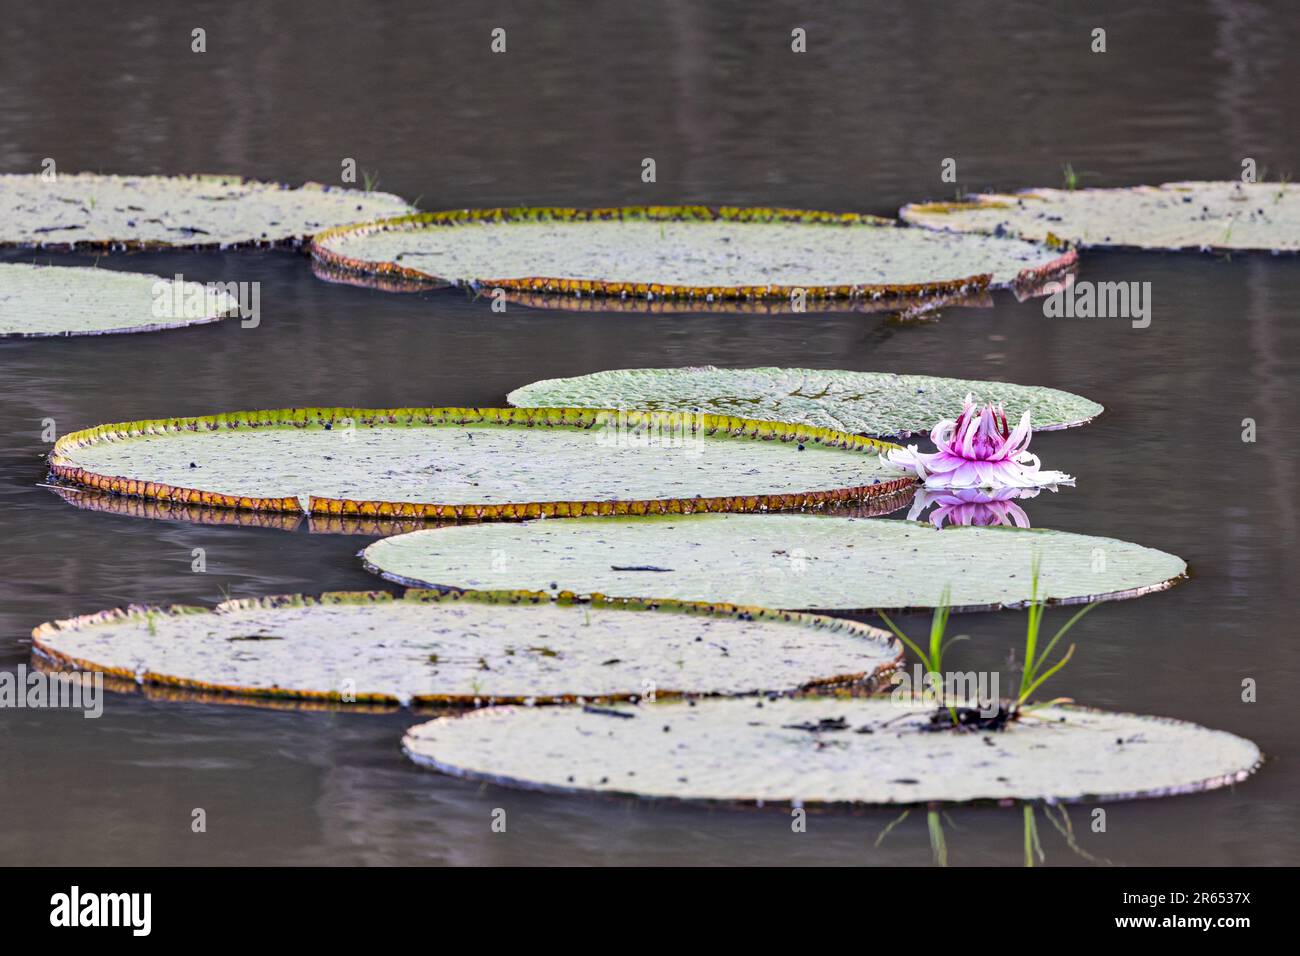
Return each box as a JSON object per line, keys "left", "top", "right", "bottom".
{"left": 31, "top": 588, "right": 905, "bottom": 709}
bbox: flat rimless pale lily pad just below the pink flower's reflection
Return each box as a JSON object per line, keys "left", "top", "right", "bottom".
{"left": 363, "top": 515, "right": 1187, "bottom": 611}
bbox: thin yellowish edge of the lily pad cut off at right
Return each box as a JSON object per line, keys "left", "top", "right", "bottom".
{"left": 898, "top": 179, "right": 1300, "bottom": 252}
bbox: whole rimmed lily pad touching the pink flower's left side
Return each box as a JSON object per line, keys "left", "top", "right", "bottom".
{"left": 49, "top": 408, "right": 914, "bottom": 520}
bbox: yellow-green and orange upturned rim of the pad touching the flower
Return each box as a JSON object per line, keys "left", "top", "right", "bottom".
{"left": 49, "top": 407, "right": 917, "bottom": 522}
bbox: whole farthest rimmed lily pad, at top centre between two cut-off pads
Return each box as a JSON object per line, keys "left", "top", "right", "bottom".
{"left": 312, "top": 206, "right": 1074, "bottom": 300}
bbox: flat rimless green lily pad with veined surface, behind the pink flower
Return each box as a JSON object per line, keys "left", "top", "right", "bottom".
{"left": 506, "top": 365, "right": 1102, "bottom": 437}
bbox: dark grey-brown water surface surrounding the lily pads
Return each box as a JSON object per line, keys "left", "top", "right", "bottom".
{"left": 0, "top": 0, "right": 1300, "bottom": 865}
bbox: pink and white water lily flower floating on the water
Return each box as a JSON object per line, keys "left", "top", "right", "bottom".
{"left": 885, "top": 394, "right": 1074, "bottom": 489}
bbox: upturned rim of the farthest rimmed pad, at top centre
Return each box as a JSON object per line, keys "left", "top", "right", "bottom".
{"left": 311, "top": 206, "right": 1078, "bottom": 302}
